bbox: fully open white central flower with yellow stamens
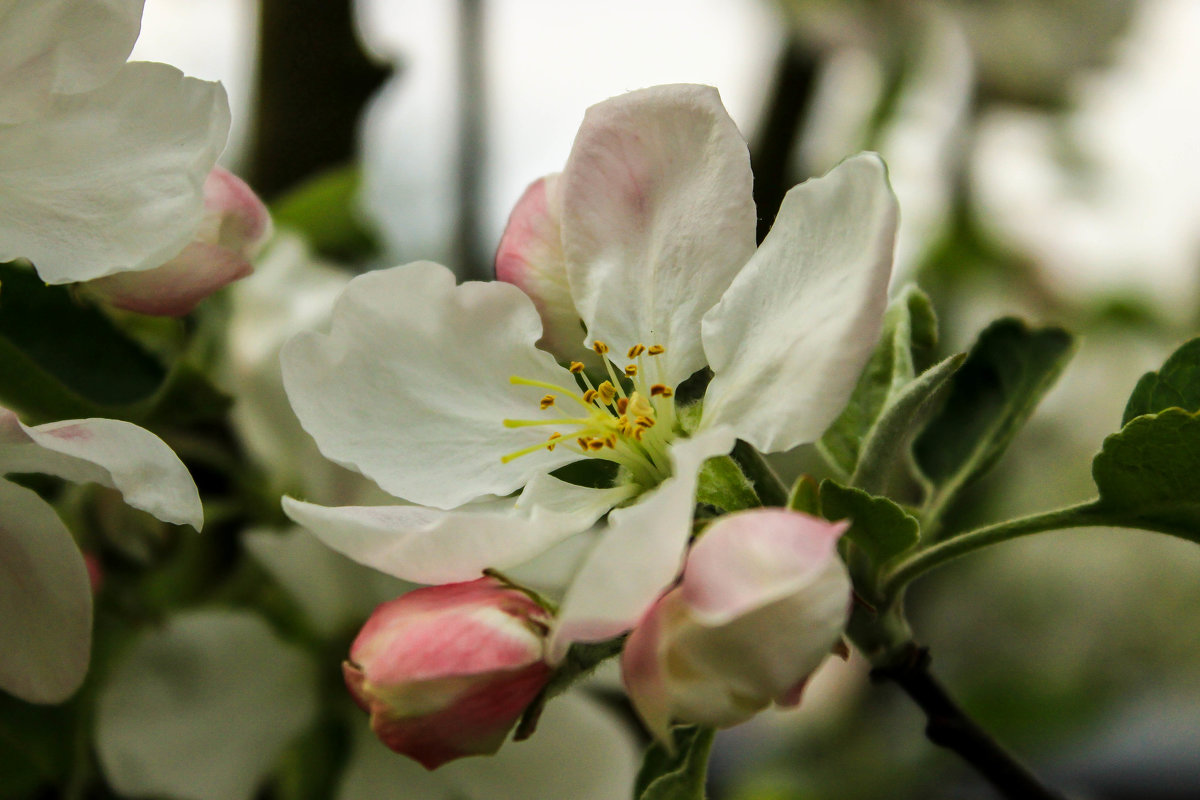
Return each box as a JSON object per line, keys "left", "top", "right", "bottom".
{"left": 283, "top": 85, "right": 896, "bottom": 657}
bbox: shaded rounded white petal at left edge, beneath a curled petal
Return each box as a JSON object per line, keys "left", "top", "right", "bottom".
{"left": 0, "top": 479, "right": 91, "bottom": 703}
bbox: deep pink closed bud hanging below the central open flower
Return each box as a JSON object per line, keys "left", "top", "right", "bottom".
{"left": 342, "top": 578, "right": 551, "bottom": 769}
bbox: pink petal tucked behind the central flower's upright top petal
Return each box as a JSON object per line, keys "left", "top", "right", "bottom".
{"left": 496, "top": 175, "right": 590, "bottom": 361}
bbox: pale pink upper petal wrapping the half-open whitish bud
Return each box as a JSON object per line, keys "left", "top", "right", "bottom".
{"left": 682, "top": 509, "right": 850, "bottom": 626}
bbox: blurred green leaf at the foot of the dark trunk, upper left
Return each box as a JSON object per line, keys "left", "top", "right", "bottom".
{"left": 271, "top": 166, "right": 379, "bottom": 260}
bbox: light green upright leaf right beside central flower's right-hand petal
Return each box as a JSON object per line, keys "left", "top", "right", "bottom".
{"left": 817, "top": 284, "right": 937, "bottom": 476}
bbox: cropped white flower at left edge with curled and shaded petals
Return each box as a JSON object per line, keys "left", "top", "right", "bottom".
{"left": 0, "top": 408, "right": 203, "bottom": 703}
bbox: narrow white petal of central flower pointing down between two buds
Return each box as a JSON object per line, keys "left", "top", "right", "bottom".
{"left": 550, "top": 428, "right": 734, "bottom": 662}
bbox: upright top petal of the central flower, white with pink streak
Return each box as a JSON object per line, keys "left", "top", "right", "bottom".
{"left": 560, "top": 85, "right": 756, "bottom": 385}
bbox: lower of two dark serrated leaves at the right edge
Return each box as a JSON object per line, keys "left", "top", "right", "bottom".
{"left": 1092, "top": 408, "right": 1200, "bottom": 542}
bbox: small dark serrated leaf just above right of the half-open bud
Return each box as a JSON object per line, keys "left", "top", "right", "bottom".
{"left": 821, "top": 479, "right": 920, "bottom": 567}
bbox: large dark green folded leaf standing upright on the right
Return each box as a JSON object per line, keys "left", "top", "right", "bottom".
{"left": 913, "top": 318, "right": 1075, "bottom": 532}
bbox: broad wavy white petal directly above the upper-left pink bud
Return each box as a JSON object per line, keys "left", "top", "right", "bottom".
{"left": 0, "top": 62, "right": 229, "bottom": 283}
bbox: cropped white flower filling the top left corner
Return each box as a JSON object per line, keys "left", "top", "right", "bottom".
{"left": 0, "top": 0, "right": 229, "bottom": 283}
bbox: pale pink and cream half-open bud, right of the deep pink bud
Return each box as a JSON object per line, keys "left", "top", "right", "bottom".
{"left": 622, "top": 509, "right": 851, "bottom": 741}
